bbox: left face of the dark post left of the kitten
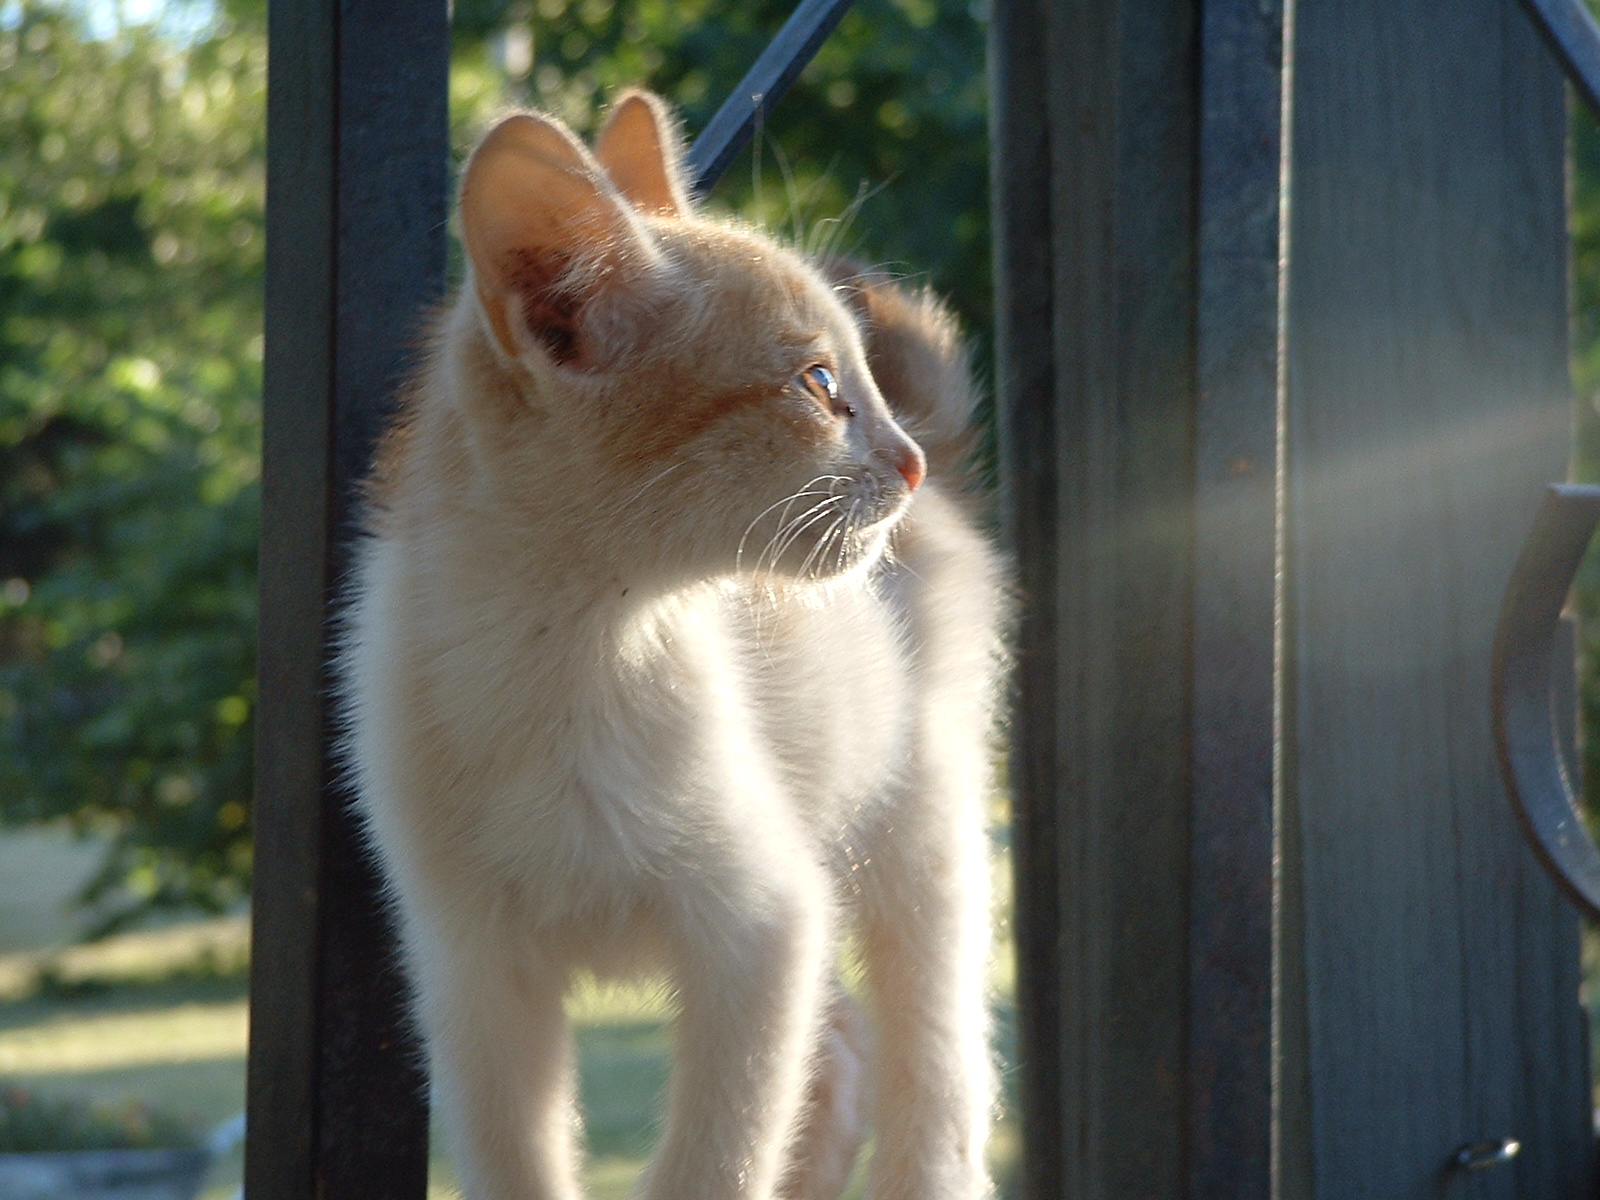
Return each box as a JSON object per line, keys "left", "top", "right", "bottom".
{"left": 245, "top": 0, "right": 334, "bottom": 1200}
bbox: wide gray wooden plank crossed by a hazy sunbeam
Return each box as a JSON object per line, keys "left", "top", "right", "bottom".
{"left": 1286, "top": 0, "right": 1594, "bottom": 1200}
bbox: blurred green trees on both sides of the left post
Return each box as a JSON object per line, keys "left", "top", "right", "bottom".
{"left": 0, "top": 0, "right": 990, "bottom": 930}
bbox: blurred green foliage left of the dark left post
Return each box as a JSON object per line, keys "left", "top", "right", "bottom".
{"left": 0, "top": 2, "right": 266, "bottom": 926}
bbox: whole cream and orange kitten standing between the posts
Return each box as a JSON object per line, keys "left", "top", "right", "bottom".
{"left": 341, "top": 93, "right": 1003, "bottom": 1200}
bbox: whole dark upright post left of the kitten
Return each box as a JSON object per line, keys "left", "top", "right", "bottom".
{"left": 245, "top": 0, "right": 450, "bottom": 1200}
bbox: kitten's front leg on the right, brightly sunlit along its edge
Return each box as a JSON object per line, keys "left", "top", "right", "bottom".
{"left": 642, "top": 830, "right": 832, "bottom": 1200}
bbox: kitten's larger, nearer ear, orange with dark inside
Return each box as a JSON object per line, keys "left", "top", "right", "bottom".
{"left": 461, "top": 114, "right": 650, "bottom": 363}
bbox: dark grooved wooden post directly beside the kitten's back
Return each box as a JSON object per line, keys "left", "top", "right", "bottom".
{"left": 995, "top": 0, "right": 1197, "bottom": 1200}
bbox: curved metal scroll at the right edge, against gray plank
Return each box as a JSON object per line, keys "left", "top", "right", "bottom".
{"left": 1490, "top": 483, "right": 1600, "bottom": 917}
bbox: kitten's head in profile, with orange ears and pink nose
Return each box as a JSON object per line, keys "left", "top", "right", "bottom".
{"left": 461, "top": 93, "right": 925, "bottom": 578}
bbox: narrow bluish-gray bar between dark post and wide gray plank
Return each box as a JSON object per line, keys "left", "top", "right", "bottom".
{"left": 1187, "top": 0, "right": 1283, "bottom": 1200}
